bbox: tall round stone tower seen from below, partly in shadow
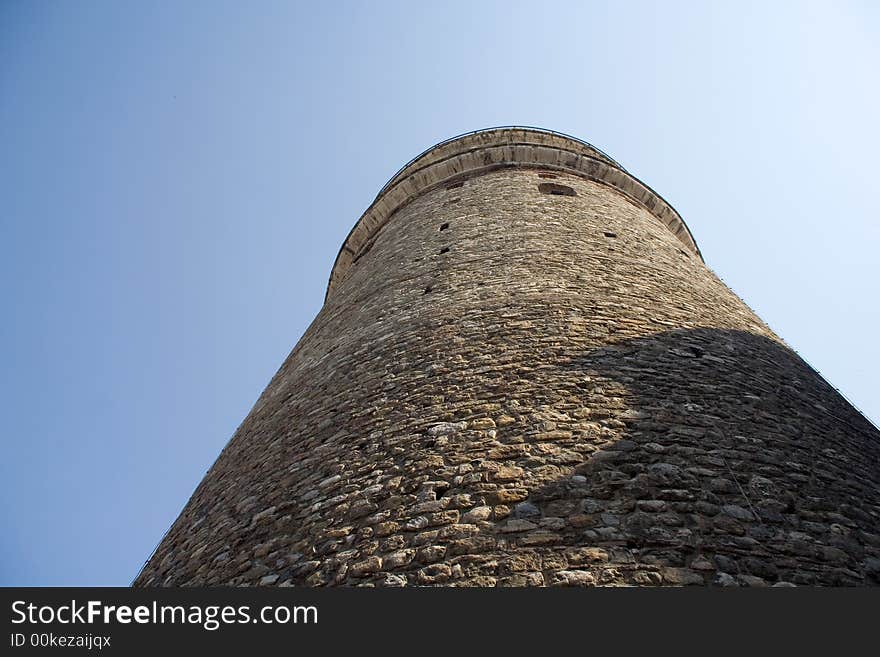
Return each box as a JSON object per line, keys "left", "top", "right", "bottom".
{"left": 135, "top": 128, "right": 880, "bottom": 586}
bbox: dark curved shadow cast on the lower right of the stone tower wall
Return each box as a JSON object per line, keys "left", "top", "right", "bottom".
{"left": 482, "top": 328, "right": 880, "bottom": 585}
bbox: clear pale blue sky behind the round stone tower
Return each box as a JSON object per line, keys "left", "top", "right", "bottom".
{"left": 0, "top": 0, "right": 880, "bottom": 585}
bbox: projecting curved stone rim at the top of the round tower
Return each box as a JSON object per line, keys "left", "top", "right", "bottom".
{"left": 324, "top": 126, "right": 703, "bottom": 302}
